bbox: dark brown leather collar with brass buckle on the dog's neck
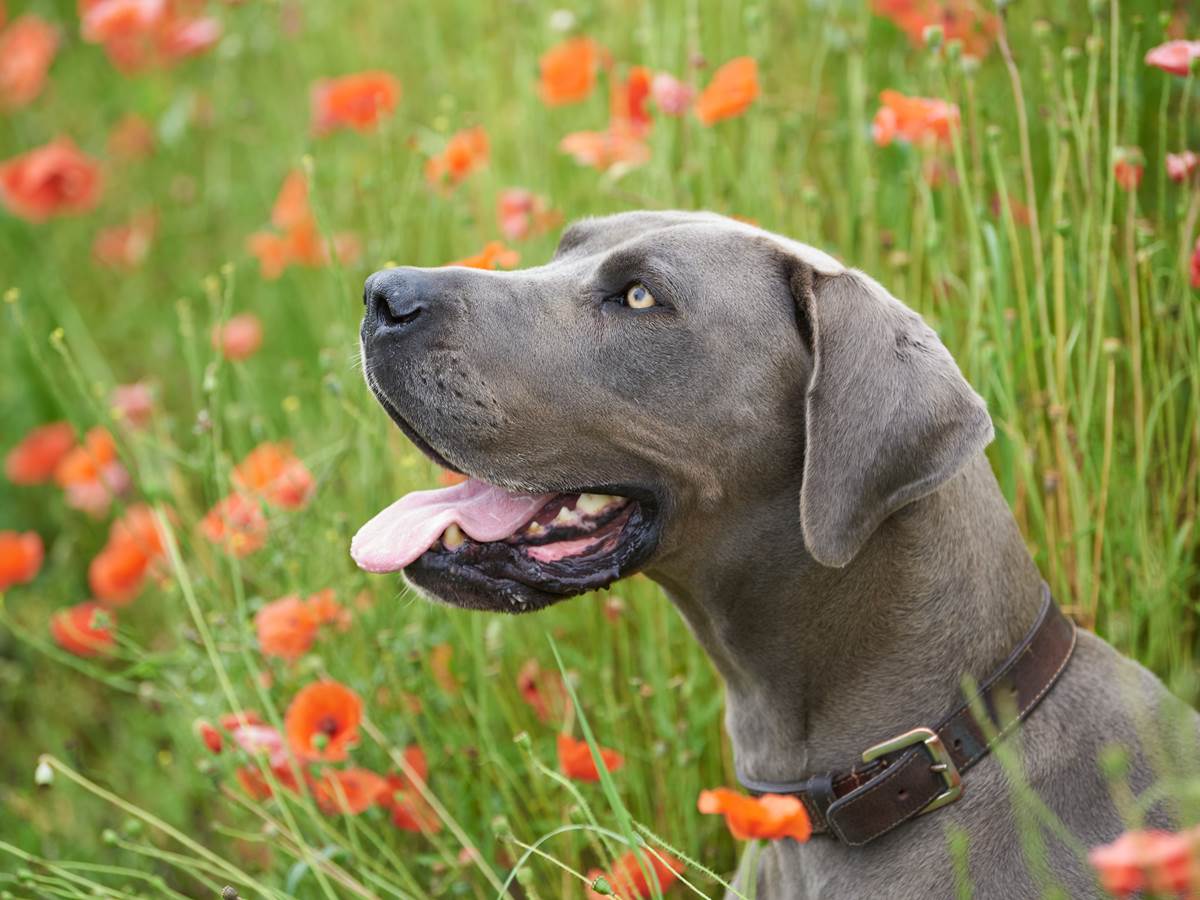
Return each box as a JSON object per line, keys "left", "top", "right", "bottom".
{"left": 738, "top": 584, "right": 1075, "bottom": 847}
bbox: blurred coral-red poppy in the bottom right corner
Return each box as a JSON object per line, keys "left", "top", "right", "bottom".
{"left": 1087, "top": 828, "right": 1200, "bottom": 896}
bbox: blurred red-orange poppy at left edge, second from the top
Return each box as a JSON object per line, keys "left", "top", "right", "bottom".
{"left": 0, "top": 138, "right": 103, "bottom": 222}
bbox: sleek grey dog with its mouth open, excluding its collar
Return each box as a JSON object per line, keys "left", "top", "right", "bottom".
{"left": 360, "top": 212, "right": 1198, "bottom": 898}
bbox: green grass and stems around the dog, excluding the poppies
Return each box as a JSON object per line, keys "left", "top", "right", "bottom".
{"left": 0, "top": 0, "right": 1200, "bottom": 898}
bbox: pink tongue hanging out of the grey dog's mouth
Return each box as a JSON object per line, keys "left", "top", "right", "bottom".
{"left": 350, "top": 479, "right": 554, "bottom": 572}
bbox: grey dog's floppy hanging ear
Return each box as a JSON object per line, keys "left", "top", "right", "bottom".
{"left": 791, "top": 263, "right": 992, "bottom": 566}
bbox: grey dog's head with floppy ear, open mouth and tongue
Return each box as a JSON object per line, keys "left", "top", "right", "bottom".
{"left": 352, "top": 212, "right": 992, "bottom": 612}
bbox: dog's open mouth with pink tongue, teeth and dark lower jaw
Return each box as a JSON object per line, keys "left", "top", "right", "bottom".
{"left": 350, "top": 479, "right": 655, "bottom": 612}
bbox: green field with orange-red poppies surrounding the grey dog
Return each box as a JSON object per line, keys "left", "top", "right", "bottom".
{"left": 7, "top": 0, "right": 1200, "bottom": 900}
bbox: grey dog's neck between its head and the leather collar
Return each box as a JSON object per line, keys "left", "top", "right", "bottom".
{"left": 648, "top": 455, "right": 1042, "bottom": 782}
